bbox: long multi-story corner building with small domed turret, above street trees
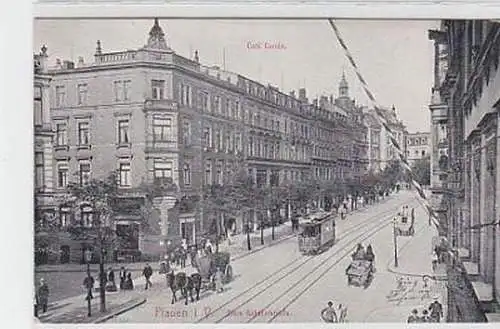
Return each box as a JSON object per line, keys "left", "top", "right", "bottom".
{"left": 39, "top": 19, "right": 374, "bottom": 262}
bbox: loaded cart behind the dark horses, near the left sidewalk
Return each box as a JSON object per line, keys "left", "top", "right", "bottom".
{"left": 196, "top": 252, "right": 233, "bottom": 289}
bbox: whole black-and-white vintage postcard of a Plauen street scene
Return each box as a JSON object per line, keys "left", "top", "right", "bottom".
{"left": 33, "top": 17, "right": 500, "bottom": 325}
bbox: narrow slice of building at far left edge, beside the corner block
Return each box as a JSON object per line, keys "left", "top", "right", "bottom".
{"left": 33, "top": 46, "right": 54, "bottom": 227}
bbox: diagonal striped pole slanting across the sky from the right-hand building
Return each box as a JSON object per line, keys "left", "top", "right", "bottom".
{"left": 328, "top": 18, "right": 454, "bottom": 256}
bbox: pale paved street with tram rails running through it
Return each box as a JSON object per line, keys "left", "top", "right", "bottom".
{"left": 110, "top": 191, "right": 438, "bottom": 323}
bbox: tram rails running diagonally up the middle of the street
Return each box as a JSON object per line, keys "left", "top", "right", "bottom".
{"left": 196, "top": 198, "right": 415, "bottom": 323}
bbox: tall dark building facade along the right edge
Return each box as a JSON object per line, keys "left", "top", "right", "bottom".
{"left": 431, "top": 20, "right": 500, "bottom": 322}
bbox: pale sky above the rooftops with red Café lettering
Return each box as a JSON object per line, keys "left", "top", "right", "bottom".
{"left": 34, "top": 19, "right": 438, "bottom": 132}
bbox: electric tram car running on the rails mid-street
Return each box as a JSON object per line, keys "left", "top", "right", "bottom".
{"left": 299, "top": 212, "right": 335, "bottom": 255}
